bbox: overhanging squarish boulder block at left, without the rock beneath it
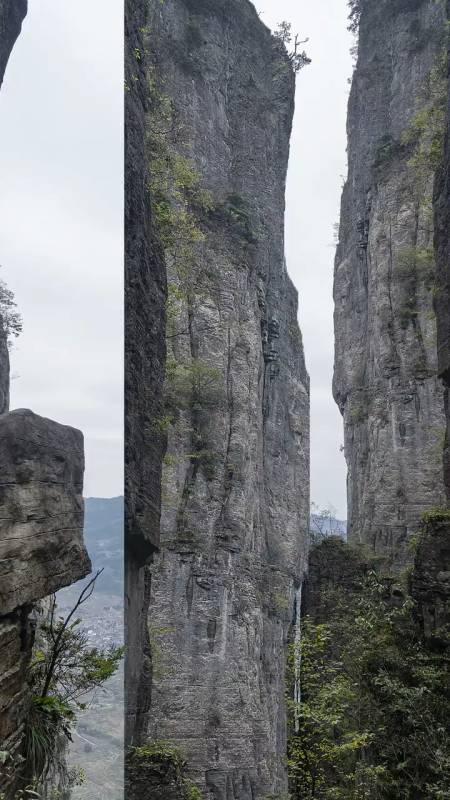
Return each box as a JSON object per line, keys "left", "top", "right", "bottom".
{"left": 0, "top": 410, "right": 90, "bottom": 613}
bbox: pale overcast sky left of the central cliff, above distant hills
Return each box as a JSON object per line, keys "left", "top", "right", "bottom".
{"left": 0, "top": 0, "right": 123, "bottom": 496}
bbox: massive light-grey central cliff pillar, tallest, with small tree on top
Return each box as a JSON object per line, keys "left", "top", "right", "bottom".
{"left": 144, "top": 0, "right": 309, "bottom": 800}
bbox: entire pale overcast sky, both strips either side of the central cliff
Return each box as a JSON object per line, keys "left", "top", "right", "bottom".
{"left": 0, "top": 0, "right": 352, "bottom": 518}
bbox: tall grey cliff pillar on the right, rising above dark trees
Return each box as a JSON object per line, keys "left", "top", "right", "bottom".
{"left": 334, "top": 0, "right": 445, "bottom": 566}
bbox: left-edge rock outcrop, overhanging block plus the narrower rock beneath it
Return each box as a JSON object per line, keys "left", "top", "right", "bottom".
{"left": 0, "top": 410, "right": 90, "bottom": 789}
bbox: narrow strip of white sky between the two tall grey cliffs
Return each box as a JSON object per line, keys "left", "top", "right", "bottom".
{"left": 255, "top": 0, "right": 353, "bottom": 519}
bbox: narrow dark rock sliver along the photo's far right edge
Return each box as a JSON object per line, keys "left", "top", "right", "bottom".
{"left": 434, "top": 3, "right": 450, "bottom": 501}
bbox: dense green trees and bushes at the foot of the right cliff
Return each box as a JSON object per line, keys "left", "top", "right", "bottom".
{"left": 288, "top": 572, "right": 450, "bottom": 800}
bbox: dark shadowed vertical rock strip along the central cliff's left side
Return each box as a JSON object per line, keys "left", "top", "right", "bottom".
{"left": 125, "top": 0, "right": 166, "bottom": 742}
